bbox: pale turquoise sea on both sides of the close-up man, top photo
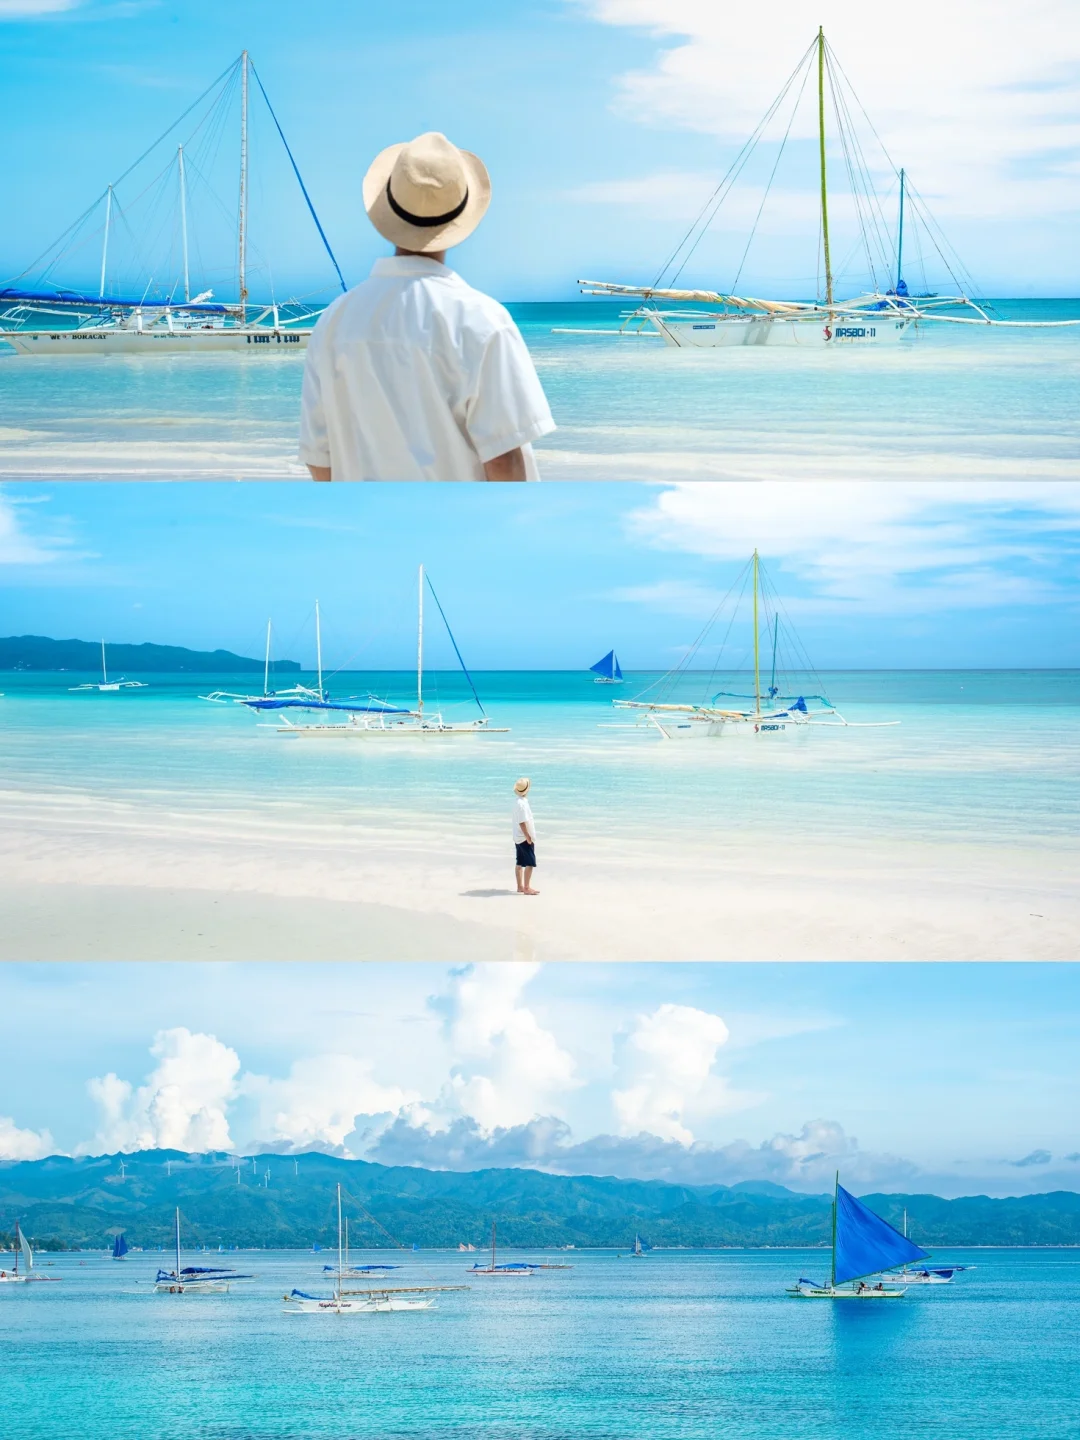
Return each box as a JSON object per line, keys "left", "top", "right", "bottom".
{"left": 0, "top": 300, "right": 1080, "bottom": 481}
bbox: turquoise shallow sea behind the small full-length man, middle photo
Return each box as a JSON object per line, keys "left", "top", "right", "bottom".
{"left": 0, "top": 671, "right": 1080, "bottom": 850}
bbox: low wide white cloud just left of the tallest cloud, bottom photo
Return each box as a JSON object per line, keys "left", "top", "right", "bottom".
{"left": 239, "top": 1054, "right": 419, "bottom": 1153}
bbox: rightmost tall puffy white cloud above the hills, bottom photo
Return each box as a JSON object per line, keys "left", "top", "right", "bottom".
{"left": 612, "top": 1005, "right": 733, "bottom": 1145}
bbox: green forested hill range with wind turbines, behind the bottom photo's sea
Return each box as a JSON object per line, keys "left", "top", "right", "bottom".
{"left": 0, "top": 1151, "right": 1080, "bottom": 1248}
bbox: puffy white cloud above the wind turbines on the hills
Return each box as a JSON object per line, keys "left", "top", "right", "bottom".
{"left": 81, "top": 1025, "right": 240, "bottom": 1152}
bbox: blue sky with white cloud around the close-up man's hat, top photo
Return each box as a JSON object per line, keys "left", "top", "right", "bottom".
{"left": 0, "top": 0, "right": 1080, "bottom": 300}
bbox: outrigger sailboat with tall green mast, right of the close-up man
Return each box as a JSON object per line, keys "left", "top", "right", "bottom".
{"left": 562, "top": 29, "right": 1080, "bottom": 348}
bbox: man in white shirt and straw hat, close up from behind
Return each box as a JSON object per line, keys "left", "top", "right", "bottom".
{"left": 300, "top": 132, "right": 554, "bottom": 480}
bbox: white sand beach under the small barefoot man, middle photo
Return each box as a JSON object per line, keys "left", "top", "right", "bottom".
{"left": 0, "top": 792, "right": 1080, "bottom": 962}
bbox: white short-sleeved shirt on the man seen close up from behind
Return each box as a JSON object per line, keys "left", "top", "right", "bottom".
{"left": 300, "top": 255, "right": 554, "bottom": 480}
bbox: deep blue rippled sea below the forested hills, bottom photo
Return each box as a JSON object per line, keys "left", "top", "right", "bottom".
{"left": 0, "top": 1250, "right": 1080, "bottom": 1440}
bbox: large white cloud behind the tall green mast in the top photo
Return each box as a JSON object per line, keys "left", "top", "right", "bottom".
{"left": 582, "top": 0, "right": 1080, "bottom": 228}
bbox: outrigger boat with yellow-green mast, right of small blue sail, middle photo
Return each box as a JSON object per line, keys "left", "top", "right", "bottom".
{"left": 612, "top": 550, "right": 899, "bottom": 740}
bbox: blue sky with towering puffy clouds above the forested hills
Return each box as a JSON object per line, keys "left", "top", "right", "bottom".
{"left": 0, "top": 963, "right": 1080, "bottom": 1194}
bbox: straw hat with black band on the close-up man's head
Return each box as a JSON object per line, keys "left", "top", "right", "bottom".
{"left": 364, "top": 131, "right": 491, "bottom": 253}
